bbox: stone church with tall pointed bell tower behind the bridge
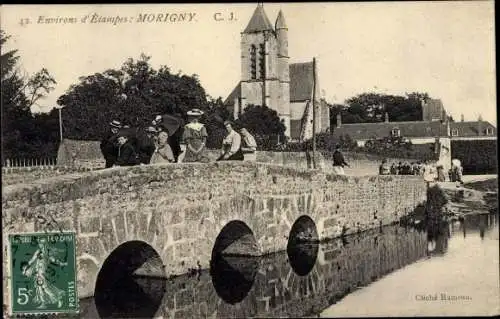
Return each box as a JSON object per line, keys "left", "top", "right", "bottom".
{"left": 224, "top": 3, "right": 330, "bottom": 141}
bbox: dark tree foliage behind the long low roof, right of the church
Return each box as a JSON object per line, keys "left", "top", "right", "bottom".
{"left": 330, "top": 92, "right": 429, "bottom": 127}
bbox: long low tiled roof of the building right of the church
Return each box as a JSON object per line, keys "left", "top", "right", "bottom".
{"left": 332, "top": 121, "right": 447, "bottom": 140}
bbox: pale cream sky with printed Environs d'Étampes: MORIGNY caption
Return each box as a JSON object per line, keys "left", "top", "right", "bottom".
{"left": 0, "top": 1, "right": 496, "bottom": 126}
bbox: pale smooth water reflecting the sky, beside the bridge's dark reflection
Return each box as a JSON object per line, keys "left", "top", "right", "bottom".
{"left": 321, "top": 214, "right": 500, "bottom": 318}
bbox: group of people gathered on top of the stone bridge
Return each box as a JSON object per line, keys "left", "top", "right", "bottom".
{"left": 101, "top": 109, "right": 257, "bottom": 168}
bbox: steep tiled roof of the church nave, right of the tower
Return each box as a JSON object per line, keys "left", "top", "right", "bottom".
{"left": 290, "top": 62, "right": 313, "bottom": 102}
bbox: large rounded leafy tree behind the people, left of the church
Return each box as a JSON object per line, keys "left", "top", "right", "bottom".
{"left": 57, "top": 54, "right": 208, "bottom": 140}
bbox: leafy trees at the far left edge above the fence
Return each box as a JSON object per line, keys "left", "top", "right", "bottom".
{"left": 0, "top": 30, "right": 59, "bottom": 159}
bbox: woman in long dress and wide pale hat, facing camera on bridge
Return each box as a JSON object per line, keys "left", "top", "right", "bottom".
{"left": 178, "top": 109, "right": 209, "bottom": 163}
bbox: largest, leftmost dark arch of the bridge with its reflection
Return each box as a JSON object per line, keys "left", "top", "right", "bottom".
{"left": 94, "top": 240, "right": 166, "bottom": 317}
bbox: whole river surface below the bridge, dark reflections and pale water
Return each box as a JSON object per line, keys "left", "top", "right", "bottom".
{"left": 80, "top": 214, "right": 500, "bottom": 318}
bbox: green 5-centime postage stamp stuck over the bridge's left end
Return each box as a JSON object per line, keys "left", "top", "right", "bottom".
{"left": 9, "top": 232, "right": 79, "bottom": 314}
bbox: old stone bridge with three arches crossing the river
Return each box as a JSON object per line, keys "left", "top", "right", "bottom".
{"left": 2, "top": 162, "right": 426, "bottom": 300}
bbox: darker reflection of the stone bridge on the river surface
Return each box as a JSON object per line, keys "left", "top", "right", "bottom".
{"left": 85, "top": 212, "right": 496, "bottom": 318}
